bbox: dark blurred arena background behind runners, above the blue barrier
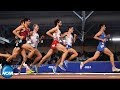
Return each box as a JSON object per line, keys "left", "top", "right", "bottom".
{"left": 0, "top": 11, "right": 120, "bottom": 64}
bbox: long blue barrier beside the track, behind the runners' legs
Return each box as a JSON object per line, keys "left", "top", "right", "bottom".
{"left": 14, "top": 61, "right": 120, "bottom": 73}
